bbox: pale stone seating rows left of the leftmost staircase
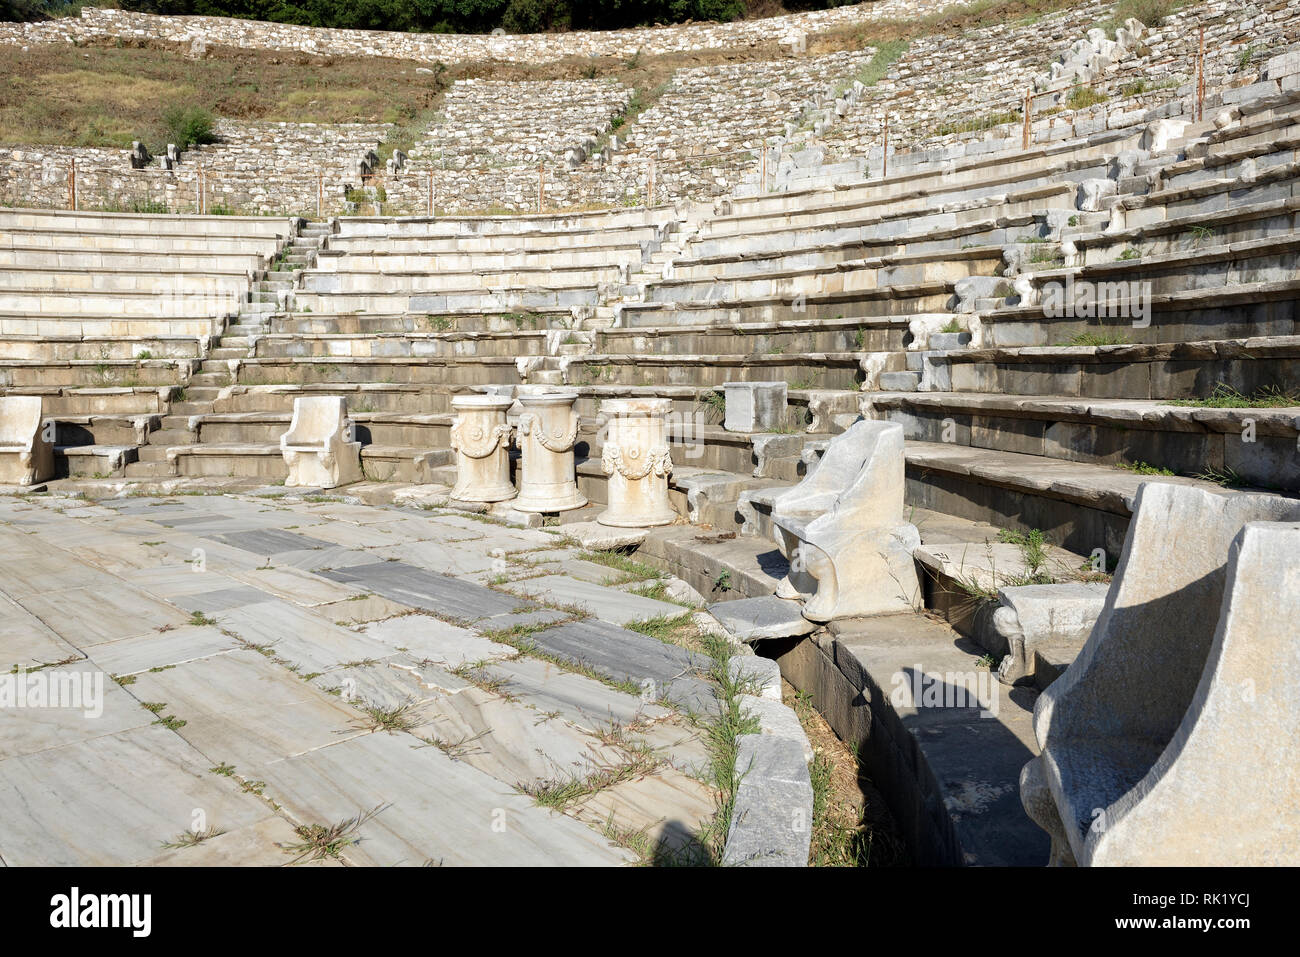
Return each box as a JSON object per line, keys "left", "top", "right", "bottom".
{"left": 0, "top": 209, "right": 296, "bottom": 476}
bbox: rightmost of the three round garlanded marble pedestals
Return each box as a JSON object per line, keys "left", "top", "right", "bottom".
{"left": 595, "top": 399, "right": 677, "bottom": 528}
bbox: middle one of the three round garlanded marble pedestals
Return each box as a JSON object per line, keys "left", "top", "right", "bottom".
{"left": 515, "top": 393, "right": 586, "bottom": 512}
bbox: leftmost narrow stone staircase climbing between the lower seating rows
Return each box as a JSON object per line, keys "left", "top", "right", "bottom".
{"left": 124, "top": 222, "right": 333, "bottom": 479}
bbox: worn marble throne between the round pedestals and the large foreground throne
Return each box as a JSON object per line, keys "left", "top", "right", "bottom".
{"left": 771, "top": 419, "right": 920, "bottom": 622}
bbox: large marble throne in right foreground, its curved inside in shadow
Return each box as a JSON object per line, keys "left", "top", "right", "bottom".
{"left": 1021, "top": 482, "right": 1300, "bottom": 866}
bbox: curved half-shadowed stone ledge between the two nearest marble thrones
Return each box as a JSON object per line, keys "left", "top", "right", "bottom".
{"left": 771, "top": 614, "right": 1049, "bottom": 866}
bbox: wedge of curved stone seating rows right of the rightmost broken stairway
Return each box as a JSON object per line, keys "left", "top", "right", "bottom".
{"left": 826, "top": 96, "right": 1300, "bottom": 555}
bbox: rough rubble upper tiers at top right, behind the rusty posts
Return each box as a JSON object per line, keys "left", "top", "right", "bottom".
{"left": 806, "top": 3, "right": 1300, "bottom": 181}
